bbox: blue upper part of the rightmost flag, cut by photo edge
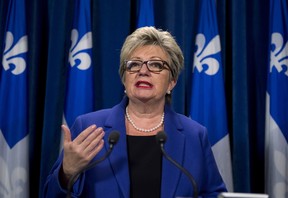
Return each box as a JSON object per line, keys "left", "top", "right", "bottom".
{"left": 267, "top": 0, "right": 288, "bottom": 142}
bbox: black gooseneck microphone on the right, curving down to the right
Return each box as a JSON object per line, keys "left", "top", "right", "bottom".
{"left": 156, "top": 131, "right": 198, "bottom": 198}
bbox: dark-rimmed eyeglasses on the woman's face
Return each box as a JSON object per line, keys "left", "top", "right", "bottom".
{"left": 125, "top": 60, "right": 170, "bottom": 73}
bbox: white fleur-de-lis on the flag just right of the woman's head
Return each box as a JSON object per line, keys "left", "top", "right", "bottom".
{"left": 193, "top": 34, "right": 221, "bottom": 75}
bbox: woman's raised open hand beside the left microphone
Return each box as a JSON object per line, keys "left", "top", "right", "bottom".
{"left": 61, "top": 125, "right": 105, "bottom": 186}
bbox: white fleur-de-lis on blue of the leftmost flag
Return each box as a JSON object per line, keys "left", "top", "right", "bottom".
{"left": 2, "top": 32, "right": 28, "bottom": 75}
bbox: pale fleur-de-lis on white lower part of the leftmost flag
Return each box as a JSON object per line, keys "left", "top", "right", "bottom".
{"left": 0, "top": 156, "right": 28, "bottom": 198}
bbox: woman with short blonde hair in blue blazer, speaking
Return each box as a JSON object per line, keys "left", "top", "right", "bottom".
{"left": 45, "top": 27, "right": 226, "bottom": 198}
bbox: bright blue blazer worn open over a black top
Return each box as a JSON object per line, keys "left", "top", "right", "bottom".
{"left": 43, "top": 97, "right": 226, "bottom": 198}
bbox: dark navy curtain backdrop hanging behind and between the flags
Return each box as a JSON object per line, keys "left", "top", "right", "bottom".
{"left": 0, "top": 0, "right": 272, "bottom": 194}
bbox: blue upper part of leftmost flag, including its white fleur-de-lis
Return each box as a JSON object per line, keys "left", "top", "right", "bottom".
{"left": 0, "top": 0, "right": 29, "bottom": 148}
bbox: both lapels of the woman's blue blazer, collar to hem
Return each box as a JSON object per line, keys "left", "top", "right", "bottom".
{"left": 105, "top": 97, "right": 185, "bottom": 198}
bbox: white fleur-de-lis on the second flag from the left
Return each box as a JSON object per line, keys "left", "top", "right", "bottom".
{"left": 69, "top": 29, "right": 92, "bottom": 70}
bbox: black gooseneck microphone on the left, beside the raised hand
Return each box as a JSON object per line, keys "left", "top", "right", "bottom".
{"left": 66, "top": 131, "right": 120, "bottom": 198}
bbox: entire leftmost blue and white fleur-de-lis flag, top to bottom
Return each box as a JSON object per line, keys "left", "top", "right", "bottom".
{"left": 0, "top": 0, "right": 29, "bottom": 198}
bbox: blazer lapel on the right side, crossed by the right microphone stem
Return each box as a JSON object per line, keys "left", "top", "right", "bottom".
{"left": 161, "top": 108, "right": 185, "bottom": 198}
